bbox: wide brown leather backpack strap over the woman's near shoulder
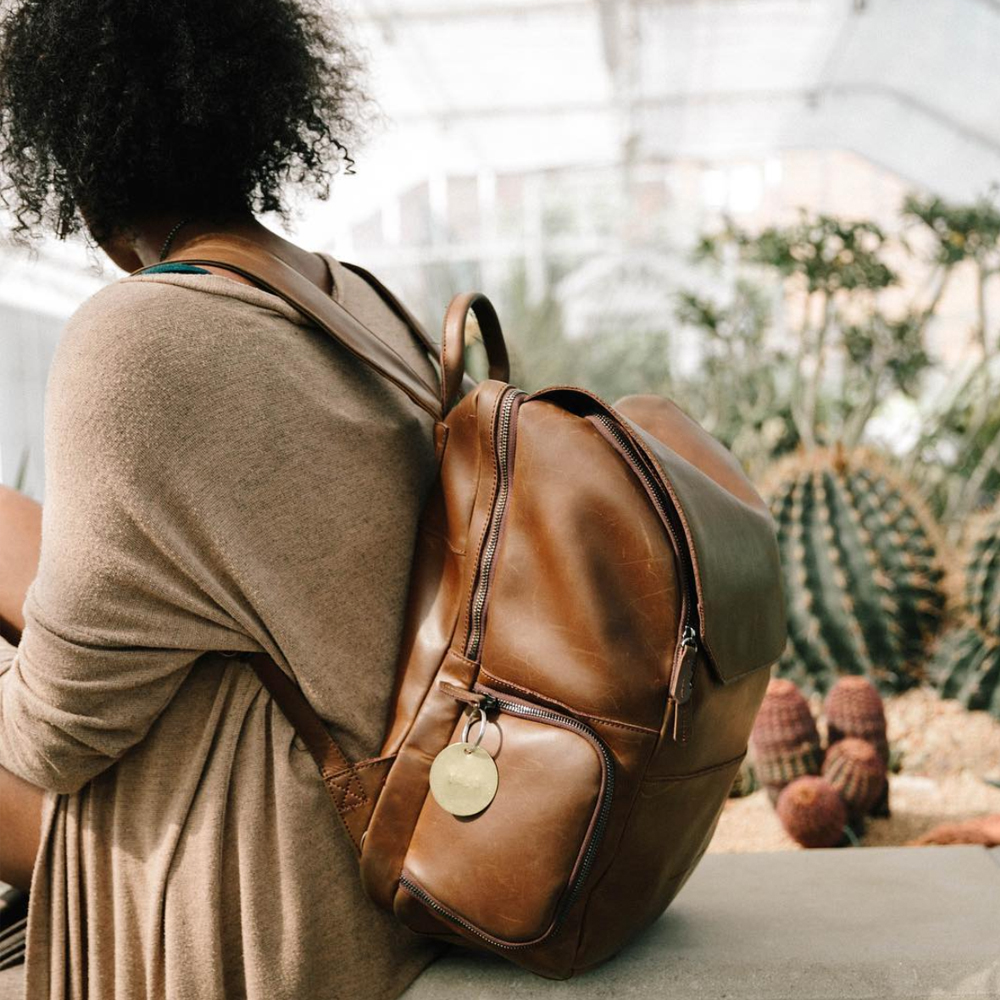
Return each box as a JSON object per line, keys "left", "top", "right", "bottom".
{"left": 133, "top": 235, "right": 441, "bottom": 420}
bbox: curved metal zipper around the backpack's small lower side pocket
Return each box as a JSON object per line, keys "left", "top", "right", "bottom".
{"left": 399, "top": 692, "right": 615, "bottom": 951}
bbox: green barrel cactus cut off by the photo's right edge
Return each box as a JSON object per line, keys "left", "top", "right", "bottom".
{"left": 932, "top": 506, "right": 1000, "bottom": 718}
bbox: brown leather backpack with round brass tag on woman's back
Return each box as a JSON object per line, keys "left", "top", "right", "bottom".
{"left": 145, "top": 238, "right": 785, "bottom": 978}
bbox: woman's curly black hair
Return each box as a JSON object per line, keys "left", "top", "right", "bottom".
{"left": 0, "top": 0, "right": 367, "bottom": 242}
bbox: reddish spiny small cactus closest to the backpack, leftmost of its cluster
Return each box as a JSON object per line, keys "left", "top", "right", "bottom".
{"left": 750, "top": 678, "right": 823, "bottom": 802}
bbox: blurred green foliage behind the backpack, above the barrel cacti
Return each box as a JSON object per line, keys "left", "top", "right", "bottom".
{"left": 488, "top": 192, "right": 1000, "bottom": 539}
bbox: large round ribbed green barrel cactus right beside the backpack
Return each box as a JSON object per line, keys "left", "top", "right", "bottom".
{"left": 764, "top": 449, "right": 945, "bottom": 693}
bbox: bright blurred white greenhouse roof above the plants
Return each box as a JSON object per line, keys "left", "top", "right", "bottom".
{"left": 334, "top": 0, "right": 1000, "bottom": 198}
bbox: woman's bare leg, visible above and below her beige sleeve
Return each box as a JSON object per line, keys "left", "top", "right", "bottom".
{"left": 0, "top": 486, "right": 43, "bottom": 890}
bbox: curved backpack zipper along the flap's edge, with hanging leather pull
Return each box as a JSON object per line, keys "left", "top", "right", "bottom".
{"left": 594, "top": 413, "right": 699, "bottom": 743}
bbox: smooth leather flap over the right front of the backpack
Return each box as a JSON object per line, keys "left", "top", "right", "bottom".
{"left": 614, "top": 396, "right": 786, "bottom": 682}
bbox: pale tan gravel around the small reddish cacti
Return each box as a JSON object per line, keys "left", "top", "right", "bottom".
{"left": 709, "top": 689, "right": 1000, "bottom": 853}
